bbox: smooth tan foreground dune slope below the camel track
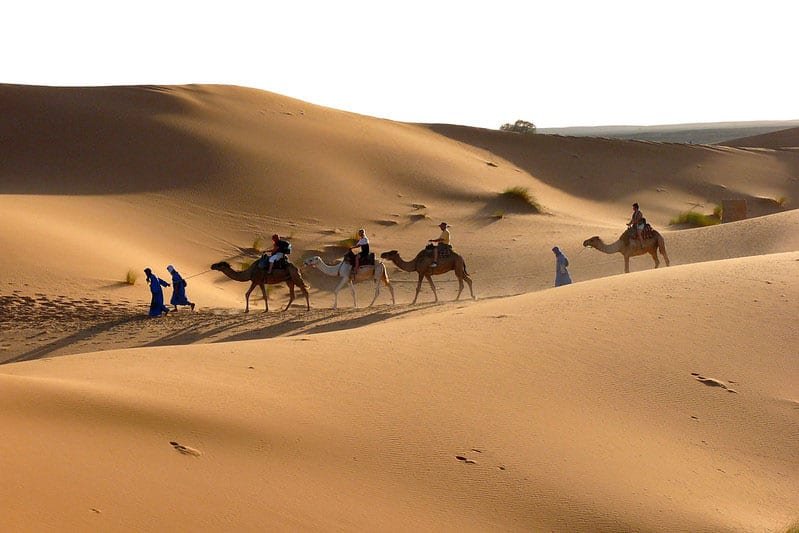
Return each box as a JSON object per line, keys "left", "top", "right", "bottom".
{"left": 0, "top": 253, "right": 799, "bottom": 531}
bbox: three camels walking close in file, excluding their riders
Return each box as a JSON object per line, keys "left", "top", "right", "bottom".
{"left": 211, "top": 244, "right": 475, "bottom": 313}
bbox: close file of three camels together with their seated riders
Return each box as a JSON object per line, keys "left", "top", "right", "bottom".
{"left": 211, "top": 222, "right": 475, "bottom": 313}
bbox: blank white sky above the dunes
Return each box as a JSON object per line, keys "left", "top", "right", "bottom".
{"left": 6, "top": 0, "right": 799, "bottom": 129}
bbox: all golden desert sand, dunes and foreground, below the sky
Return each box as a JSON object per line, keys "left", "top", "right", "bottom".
{"left": 0, "top": 85, "right": 799, "bottom": 531}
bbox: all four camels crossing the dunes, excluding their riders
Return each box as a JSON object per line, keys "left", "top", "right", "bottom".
{"left": 211, "top": 231, "right": 669, "bottom": 313}
